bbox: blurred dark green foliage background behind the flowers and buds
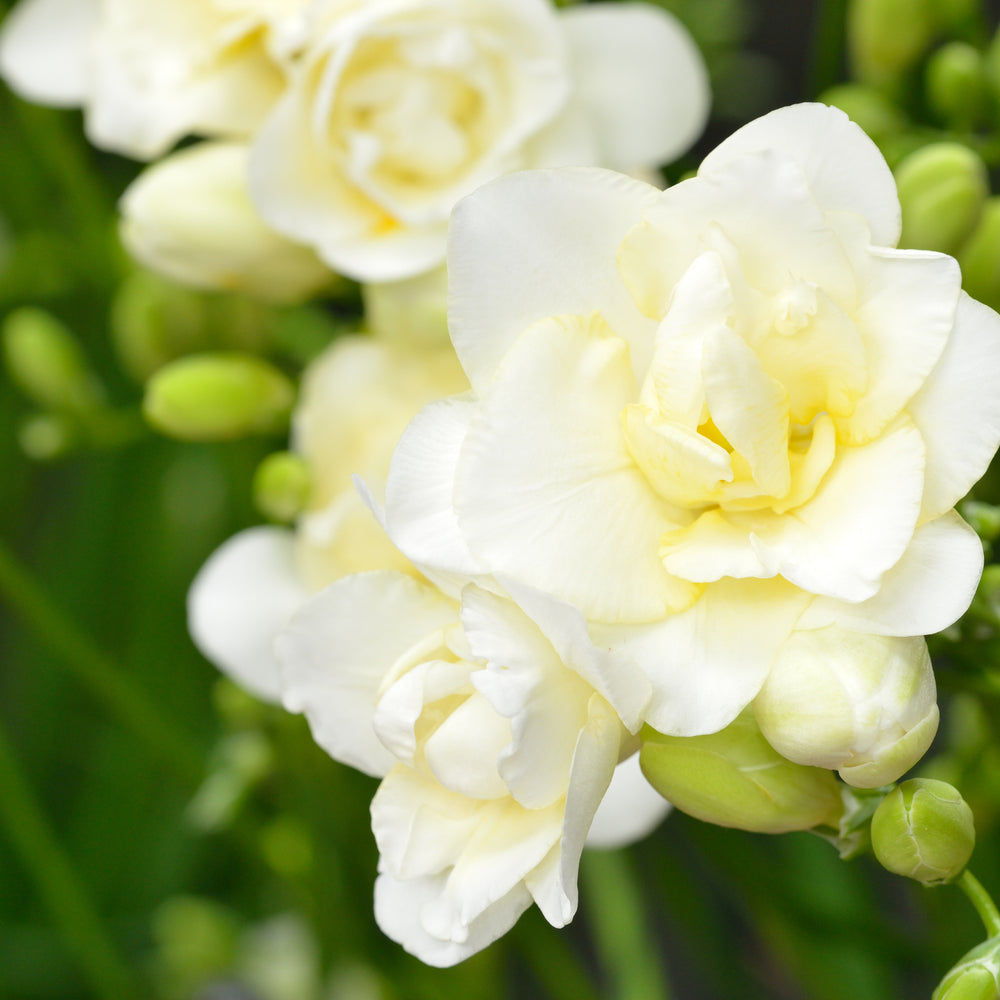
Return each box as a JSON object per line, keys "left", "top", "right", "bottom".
{"left": 0, "top": 0, "right": 1000, "bottom": 1000}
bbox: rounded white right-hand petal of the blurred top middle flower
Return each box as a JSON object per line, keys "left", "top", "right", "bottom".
{"left": 560, "top": 3, "right": 710, "bottom": 170}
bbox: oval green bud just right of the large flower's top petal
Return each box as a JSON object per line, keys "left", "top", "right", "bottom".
{"left": 895, "top": 142, "right": 990, "bottom": 253}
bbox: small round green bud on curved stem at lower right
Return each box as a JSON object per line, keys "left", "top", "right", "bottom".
{"left": 872, "top": 778, "right": 976, "bottom": 885}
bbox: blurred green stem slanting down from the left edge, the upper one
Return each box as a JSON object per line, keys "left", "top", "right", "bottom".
{"left": 0, "top": 540, "right": 205, "bottom": 785}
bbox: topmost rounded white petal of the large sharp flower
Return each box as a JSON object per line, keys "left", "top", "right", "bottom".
{"left": 699, "top": 104, "right": 902, "bottom": 247}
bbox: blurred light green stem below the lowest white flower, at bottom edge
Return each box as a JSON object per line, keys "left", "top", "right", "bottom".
{"left": 580, "top": 851, "right": 670, "bottom": 1000}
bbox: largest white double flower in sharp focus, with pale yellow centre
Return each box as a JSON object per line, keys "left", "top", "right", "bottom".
{"left": 386, "top": 105, "right": 1000, "bottom": 762}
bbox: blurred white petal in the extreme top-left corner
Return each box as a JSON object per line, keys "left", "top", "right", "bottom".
{"left": 0, "top": 0, "right": 99, "bottom": 107}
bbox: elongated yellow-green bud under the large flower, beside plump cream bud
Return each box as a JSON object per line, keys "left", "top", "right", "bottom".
{"left": 639, "top": 711, "right": 842, "bottom": 833}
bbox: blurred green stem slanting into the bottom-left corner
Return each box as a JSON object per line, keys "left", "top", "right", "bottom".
{"left": 0, "top": 726, "right": 140, "bottom": 1000}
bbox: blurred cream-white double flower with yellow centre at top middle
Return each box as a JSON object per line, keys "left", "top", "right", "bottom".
{"left": 251, "top": 0, "right": 708, "bottom": 282}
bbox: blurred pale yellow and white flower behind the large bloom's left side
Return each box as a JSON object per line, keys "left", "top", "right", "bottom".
{"left": 188, "top": 336, "right": 468, "bottom": 701}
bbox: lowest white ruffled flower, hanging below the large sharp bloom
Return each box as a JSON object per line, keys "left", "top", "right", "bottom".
{"left": 278, "top": 572, "right": 666, "bottom": 965}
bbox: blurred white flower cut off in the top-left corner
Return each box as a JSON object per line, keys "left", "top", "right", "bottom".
{"left": 0, "top": 0, "right": 309, "bottom": 159}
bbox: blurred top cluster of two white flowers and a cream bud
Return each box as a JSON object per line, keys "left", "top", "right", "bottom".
{"left": 0, "top": 0, "right": 708, "bottom": 286}
